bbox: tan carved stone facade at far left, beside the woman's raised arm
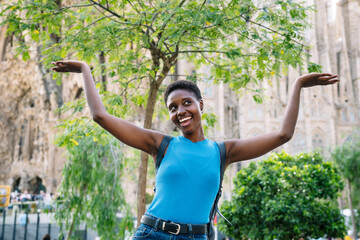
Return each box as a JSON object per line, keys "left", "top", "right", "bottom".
{"left": 0, "top": 27, "right": 81, "bottom": 193}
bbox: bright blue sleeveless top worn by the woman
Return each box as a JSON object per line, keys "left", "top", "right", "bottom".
{"left": 147, "top": 136, "right": 220, "bottom": 224}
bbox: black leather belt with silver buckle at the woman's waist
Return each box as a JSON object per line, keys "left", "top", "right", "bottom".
{"left": 141, "top": 215, "right": 207, "bottom": 235}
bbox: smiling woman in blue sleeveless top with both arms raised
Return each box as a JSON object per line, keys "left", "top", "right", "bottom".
{"left": 53, "top": 61, "right": 339, "bottom": 239}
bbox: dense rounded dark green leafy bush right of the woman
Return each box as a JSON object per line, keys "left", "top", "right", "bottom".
{"left": 220, "top": 152, "right": 345, "bottom": 240}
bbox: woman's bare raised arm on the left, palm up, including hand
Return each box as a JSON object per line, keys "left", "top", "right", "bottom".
{"left": 52, "top": 61, "right": 164, "bottom": 156}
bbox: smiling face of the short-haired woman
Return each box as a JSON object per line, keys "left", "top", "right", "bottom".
{"left": 166, "top": 89, "right": 204, "bottom": 138}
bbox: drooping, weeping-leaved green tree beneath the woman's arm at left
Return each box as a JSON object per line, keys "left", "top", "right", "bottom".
{"left": 55, "top": 118, "right": 133, "bottom": 239}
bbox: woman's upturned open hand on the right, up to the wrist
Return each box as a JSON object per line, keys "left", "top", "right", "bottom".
{"left": 297, "top": 73, "right": 340, "bottom": 87}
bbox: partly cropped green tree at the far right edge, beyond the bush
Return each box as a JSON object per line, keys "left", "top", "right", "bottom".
{"left": 331, "top": 130, "right": 360, "bottom": 239}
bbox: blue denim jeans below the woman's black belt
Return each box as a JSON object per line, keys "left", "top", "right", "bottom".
{"left": 132, "top": 215, "right": 207, "bottom": 240}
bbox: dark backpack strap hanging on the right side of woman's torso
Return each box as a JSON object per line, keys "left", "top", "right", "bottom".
{"left": 209, "top": 141, "right": 232, "bottom": 225}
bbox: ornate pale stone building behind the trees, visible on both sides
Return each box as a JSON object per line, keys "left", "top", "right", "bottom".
{"left": 0, "top": 0, "right": 360, "bottom": 201}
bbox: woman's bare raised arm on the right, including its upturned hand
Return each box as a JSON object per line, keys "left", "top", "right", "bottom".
{"left": 225, "top": 73, "right": 339, "bottom": 165}
